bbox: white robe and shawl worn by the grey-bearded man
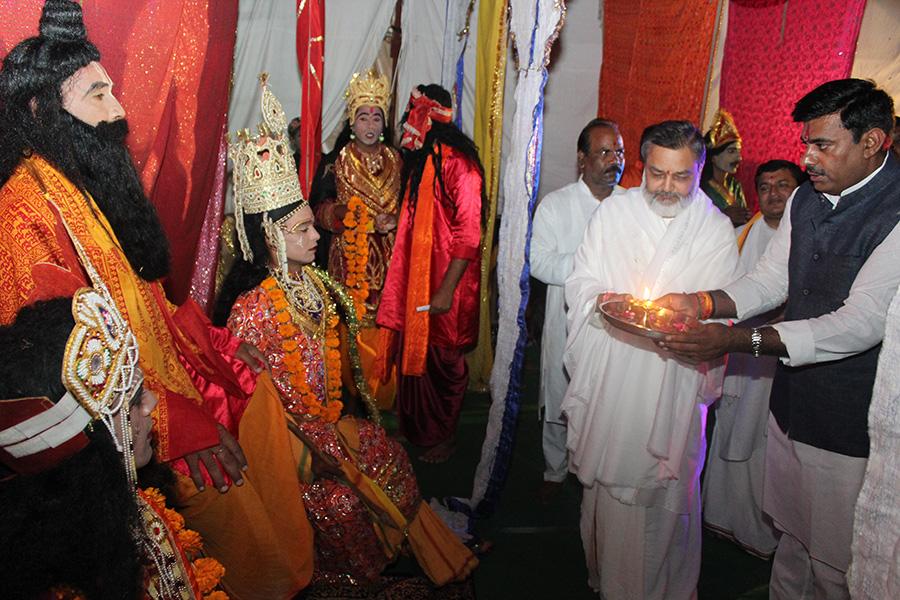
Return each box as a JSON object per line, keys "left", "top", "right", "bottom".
{"left": 562, "top": 188, "right": 738, "bottom": 600}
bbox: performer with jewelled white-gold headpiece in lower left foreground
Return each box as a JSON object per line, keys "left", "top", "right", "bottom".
{"left": 0, "top": 288, "right": 221, "bottom": 600}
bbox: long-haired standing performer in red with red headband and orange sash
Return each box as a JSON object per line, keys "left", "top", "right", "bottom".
{"left": 376, "top": 84, "right": 485, "bottom": 462}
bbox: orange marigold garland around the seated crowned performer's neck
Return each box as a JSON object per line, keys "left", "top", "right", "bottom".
{"left": 260, "top": 277, "right": 344, "bottom": 423}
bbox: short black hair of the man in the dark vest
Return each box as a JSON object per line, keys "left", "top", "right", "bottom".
{"left": 791, "top": 79, "right": 894, "bottom": 143}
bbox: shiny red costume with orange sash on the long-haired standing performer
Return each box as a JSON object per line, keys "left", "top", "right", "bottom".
{"left": 376, "top": 145, "right": 482, "bottom": 446}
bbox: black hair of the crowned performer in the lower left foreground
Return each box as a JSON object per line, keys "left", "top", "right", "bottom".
{"left": 0, "top": 298, "right": 143, "bottom": 599}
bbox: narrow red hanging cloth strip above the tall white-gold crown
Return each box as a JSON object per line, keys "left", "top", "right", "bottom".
{"left": 297, "top": 0, "right": 325, "bottom": 195}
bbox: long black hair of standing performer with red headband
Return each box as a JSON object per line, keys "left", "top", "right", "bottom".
{"left": 400, "top": 83, "right": 488, "bottom": 224}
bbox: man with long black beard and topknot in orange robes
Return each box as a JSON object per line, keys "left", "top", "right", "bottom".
{"left": 0, "top": 0, "right": 312, "bottom": 598}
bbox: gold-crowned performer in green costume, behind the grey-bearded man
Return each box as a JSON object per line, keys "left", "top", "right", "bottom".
{"left": 700, "top": 109, "right": 750, "bottom": 227}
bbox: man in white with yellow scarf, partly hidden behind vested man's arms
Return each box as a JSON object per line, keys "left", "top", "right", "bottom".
{"left": 703, "top": 160, "right": 804, "bottom": 558}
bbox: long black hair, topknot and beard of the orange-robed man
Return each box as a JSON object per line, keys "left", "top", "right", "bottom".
{"left": 0, "top": 0, "right": 170, "bottom": 281}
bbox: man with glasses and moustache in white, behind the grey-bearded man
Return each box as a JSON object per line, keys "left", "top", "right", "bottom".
{"left": 530, "top": 119, "right": 625, "bottom": 494}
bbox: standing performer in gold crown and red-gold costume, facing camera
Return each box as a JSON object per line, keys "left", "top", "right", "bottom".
{"left": 310, "top": 71, "right": 401, "bottom": 407}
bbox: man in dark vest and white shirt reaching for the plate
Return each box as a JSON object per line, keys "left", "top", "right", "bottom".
{"left": 658, "top": 79, "right": 900, "bottom": 600}
